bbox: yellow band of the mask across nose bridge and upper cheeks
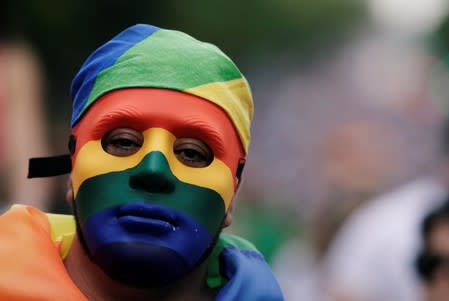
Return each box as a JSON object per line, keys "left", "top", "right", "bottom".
{"left": 72, "top": 128, "right": 234, "bottom": 210}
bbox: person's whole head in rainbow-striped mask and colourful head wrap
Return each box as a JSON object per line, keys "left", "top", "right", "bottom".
{"left": 60, "top": 25, "right": 253, "bottom": 287}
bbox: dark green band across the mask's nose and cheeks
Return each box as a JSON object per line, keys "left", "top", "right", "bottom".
{"left": 76, "top": 152, "right": 225, "bottom": 234}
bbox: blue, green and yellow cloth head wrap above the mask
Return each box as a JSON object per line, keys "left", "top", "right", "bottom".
{"left": 71, "top": 24, "right": 253, "bottom": 153}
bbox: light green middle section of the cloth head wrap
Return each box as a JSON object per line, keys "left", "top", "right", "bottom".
{"left": 83, "top": 29, "right": 242, "bottom": 111}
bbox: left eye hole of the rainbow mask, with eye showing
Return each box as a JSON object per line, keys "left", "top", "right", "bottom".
{"left": 101, "top": 128, "right": 143, "bottom": 157}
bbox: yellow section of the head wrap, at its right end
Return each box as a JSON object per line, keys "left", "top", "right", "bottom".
{"left": 184, "top": 78, "right": 253, "bottom": 153}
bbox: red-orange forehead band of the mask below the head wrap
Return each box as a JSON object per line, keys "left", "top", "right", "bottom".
{"left": 73, "top": 88, "right": 243, "bottom": 155}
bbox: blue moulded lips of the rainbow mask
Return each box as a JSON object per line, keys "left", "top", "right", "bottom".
{"left": 116, "top": 202, "right": 176, "bottom": 232}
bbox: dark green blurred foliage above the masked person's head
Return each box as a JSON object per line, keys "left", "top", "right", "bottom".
{"left": 0, "top": 0, "right": 365, "bottom": 119}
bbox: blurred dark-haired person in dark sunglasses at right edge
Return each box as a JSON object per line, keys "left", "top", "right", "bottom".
{"left": 415, "top": 199, "right": 449, "bottom": 301}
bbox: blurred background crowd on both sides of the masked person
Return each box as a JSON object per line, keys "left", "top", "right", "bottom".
{"left": 4, "top": 0, "right": 449, "bottom": 301}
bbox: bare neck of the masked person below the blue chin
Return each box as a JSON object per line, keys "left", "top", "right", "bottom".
{"left": 64, "top": 236, "right": 214, "bottom": 301}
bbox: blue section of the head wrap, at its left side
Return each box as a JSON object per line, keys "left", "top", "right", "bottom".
{"left": 70, "top": 24, "right": 159, "bottom": 126}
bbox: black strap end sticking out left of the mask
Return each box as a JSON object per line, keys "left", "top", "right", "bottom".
{"left": 28, "top": 154, "right": 72, "bottom": 179}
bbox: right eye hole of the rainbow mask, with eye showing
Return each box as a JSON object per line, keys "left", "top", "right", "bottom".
{"left": 173, "top": 138, "right": 214, "bottom": 167}
